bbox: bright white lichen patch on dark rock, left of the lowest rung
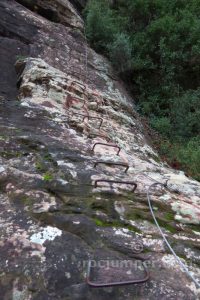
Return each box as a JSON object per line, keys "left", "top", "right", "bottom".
{"left": 30, "top": 226, "right": 62, "bottom": 245}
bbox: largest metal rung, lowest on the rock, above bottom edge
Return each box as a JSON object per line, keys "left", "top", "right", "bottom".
{"left": 86, "top": 260, "right": 150, "bottom": 288}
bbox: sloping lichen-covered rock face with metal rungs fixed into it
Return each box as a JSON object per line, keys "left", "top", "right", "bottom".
{"left": 0, "top": 0, "right": 200, "bottom": 300}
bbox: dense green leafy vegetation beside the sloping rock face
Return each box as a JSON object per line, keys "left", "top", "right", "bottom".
{"left": 85, "top": 0, "right": 200, "bottom": 180}
